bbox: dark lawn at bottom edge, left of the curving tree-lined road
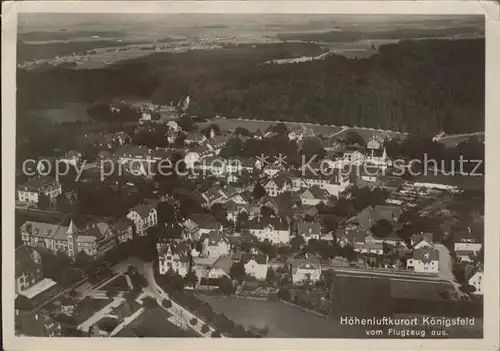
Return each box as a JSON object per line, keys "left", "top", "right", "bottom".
{"left": 116, "top": 307, "right": 197, "bottom": 338}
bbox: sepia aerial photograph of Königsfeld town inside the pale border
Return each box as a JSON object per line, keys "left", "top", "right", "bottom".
{"left": 14, "top": 13, "right": 485, "bottom": 339}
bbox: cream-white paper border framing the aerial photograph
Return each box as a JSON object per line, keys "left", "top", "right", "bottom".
{"left": 2, "top": 0, "right": 500, "bottom": 351}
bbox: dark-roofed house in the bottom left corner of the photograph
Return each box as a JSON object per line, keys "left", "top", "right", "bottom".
{"left": 14, "top": 310, "right": 62, "bottom": 337}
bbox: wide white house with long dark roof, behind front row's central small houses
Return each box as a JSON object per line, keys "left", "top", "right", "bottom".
{"left": 248, "top": 216, "right": 290, "bottom": 245}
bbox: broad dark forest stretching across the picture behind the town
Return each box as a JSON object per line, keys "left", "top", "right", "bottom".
{"left": 18, "top": 39, "right": 485, "bottom": 135}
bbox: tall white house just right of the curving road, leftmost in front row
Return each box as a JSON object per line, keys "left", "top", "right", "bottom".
{"left": 156, "top": 242, "right": 191, "bottom": 277}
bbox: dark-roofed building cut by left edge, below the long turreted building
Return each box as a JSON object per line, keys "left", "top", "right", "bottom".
{"left": 15, "top": 246, "right": 43, "bottom": 294}
